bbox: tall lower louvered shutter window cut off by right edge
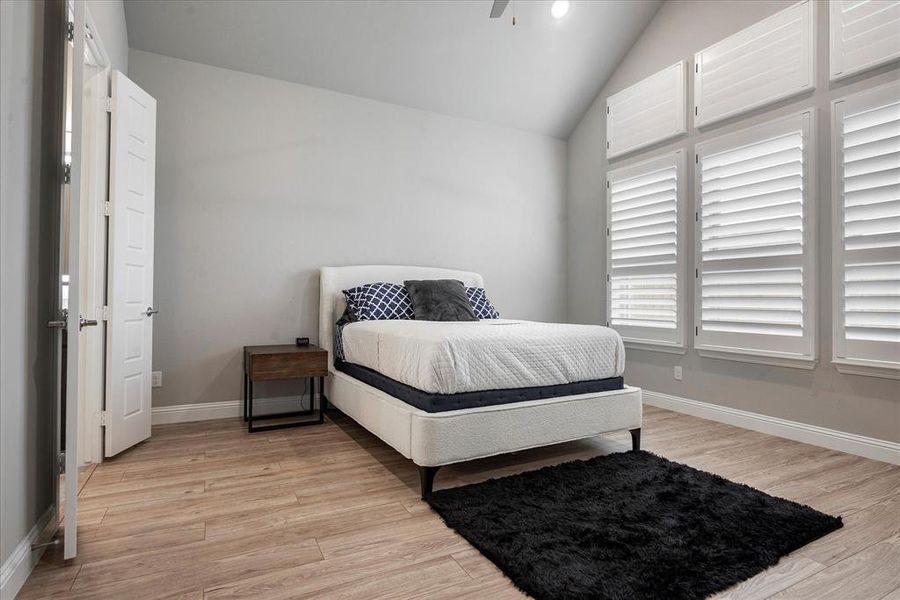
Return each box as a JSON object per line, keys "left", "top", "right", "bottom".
{"left": 832, "top": 83, "right": 900, "bottom": 378}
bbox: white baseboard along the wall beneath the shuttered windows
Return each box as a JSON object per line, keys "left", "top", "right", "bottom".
{"left": 643, "top": 390, "right": 900, "bottom": 465}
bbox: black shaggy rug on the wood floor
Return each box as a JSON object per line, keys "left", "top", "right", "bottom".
{"left": 428, "top": 451, "right": 842, "bottom": 600}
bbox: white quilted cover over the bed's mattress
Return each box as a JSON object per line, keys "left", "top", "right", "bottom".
{"left": 342, "top": 319, "right": 625, "bottom": 394}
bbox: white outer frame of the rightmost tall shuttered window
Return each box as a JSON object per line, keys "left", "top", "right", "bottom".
{"left": 830, "top": 82, "right": 900, "bottom": 379}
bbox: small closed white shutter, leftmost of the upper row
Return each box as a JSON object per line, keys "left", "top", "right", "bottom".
{"left": 606, "top": 61, "right": 687, "bottom": 158}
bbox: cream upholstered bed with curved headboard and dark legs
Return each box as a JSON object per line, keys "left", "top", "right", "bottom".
{"left": 319, "top": 265, "right": 641, "bottom": 497}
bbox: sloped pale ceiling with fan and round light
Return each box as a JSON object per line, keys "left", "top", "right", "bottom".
{"left": 125, "top": 0, "right": 660, "bottom": 138}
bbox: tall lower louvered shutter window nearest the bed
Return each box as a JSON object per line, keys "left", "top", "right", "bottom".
{"left": 606, "top": 151, "right": 684, "bottom": 349}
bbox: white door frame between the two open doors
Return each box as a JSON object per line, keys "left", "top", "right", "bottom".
{"left": 78, "top": 6, "right": 112, "bottom": 468}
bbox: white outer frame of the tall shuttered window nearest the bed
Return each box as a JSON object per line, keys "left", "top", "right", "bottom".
{"left": 604, "top": 148, "right": 687, "bottom": 354}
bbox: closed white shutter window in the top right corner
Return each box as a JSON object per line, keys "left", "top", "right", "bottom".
{"left": 829, "top": 0, "right": 900, "bottom": 81}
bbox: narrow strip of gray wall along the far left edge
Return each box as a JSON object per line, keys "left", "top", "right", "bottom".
{"left": 0, "top": 2, "right": 53, "bottom": 563}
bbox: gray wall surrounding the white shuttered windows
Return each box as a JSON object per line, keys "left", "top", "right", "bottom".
{"left": 567, "top": 0, "right": 900, "bottom": 441}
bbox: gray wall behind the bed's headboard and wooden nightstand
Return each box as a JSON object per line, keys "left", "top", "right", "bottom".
{"left": 129, "top": 50, "right": 566, "bottom": 406}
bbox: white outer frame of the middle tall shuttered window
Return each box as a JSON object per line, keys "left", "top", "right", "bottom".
{"left": 693, "top": 107, "right": 818, "bottom": 369}
